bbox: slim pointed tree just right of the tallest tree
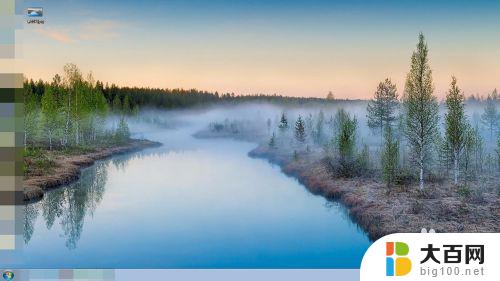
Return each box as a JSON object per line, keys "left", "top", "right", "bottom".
{"left": 444, "top": 77, "right": 467, "bottom": 184}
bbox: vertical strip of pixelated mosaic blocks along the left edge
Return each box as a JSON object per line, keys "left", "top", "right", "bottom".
{"left": 0, "top": 0, "right": 24, "bottom": 254}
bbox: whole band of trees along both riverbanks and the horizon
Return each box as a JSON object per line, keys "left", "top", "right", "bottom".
{"left": 24, "top": 34, "right": 500, "bottom": 191}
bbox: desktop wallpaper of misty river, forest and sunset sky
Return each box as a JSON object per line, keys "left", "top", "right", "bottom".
{"left": 0, "top": 0, "right": 500, "bottom": 269}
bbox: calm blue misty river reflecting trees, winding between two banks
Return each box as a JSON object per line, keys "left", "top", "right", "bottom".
{"left": 10, "top": 115, "right": 371, "bottom": 268}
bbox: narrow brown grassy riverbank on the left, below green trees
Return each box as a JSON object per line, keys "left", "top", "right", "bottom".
{"left": 23, "top": 139, "right": 161, "bottom": 202}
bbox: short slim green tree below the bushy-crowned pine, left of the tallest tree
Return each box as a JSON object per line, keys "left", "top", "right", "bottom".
{"left": 382, "top": 126, "right": 399, "bottom": 188}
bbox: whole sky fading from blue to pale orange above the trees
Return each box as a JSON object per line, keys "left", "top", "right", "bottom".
{"left": 17, "top": 0, "right": 500, "bottom": 99}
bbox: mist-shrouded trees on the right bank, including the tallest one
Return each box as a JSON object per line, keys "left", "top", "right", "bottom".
{"left": 267, "top": 34, "right": 500, "bottom": 192}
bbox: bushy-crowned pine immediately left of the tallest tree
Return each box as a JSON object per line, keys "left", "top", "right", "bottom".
{"left": 366, "top": 79, "right": 398, "bottom": 141}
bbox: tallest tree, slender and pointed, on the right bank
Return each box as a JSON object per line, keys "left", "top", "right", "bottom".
{"left": 403, "top": 33, "right": 439, "bottom": 189}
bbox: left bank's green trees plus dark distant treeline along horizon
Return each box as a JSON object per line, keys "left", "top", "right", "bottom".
{"left": 24, "top": 64, "right": 360, "bottom": 150}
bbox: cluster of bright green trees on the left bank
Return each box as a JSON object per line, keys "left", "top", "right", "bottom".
{"left": 24, "top": 64, "right": 130, "bottom": 151}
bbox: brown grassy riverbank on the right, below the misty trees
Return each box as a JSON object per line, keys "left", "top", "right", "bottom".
{"left": 249, "top": 144, "right": 500, "bottom": 240}
